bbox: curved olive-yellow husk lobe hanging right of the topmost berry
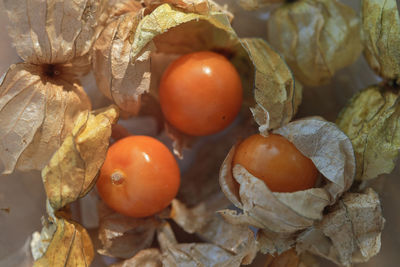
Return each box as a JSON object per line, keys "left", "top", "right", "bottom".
{"left": 242, "top": 39, "right": 296, "bottom": 128}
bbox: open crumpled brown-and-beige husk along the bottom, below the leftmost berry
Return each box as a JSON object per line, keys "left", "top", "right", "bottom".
{"left": 98, "top": 193, "right": 257, "bottom": 267}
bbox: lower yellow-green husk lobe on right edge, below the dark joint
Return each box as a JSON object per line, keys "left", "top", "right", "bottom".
{"left": 337, "top": 85, "right": 400, "bottom": 180}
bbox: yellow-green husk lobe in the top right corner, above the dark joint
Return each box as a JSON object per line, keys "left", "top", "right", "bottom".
{"left": 361, "top": 0, "right": 400, "bottom": 80}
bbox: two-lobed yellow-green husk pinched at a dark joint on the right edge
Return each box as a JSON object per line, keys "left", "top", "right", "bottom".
{"left": 337, "top": 0, "right": 400, "bottom": 181}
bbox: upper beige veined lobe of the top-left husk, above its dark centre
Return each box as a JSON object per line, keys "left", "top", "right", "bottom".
{"left": 4, "top": 0, "right": 107, "bottom": 64}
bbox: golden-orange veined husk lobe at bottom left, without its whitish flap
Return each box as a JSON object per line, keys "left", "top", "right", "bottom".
{"left": 34, "top": 218, "right": 94, "bottom": 267}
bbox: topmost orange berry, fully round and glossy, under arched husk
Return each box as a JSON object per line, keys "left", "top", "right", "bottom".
{"left": 159, "top": 51, "right": 243, "bottom": 136}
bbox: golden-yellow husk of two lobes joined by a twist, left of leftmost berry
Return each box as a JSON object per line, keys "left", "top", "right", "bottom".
{"left": 30, "top": 106, "right": 119, "bottom": 267}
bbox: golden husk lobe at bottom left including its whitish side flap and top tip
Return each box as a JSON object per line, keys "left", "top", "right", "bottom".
{"left": 31, "top": 202, "right": 94, "bottom": 267}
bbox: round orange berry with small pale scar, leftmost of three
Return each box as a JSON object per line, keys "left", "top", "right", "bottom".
{"left": 97, "top": 136, "right": 180, "bottom": 218}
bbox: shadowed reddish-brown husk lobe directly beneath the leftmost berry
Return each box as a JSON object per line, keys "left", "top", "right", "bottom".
{"left": 97, "top": 202, "right": 160, "bottom": 262}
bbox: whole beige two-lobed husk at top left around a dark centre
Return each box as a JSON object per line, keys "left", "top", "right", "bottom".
{"left": 0, "top": 0, "right": 106, "bottom": 173}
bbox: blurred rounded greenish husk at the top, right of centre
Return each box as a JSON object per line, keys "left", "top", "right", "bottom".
{"left": 268, "top": 0, "right": 362, "bottom": 86}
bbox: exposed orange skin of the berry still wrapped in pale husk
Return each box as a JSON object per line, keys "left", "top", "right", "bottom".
{"left": 233, "top": 134, "right": 318, "bottom": 192}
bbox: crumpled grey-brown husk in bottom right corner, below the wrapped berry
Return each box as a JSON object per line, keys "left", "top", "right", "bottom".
{"left": 296, "top": 189, "right": 385, "bottom": 266}
